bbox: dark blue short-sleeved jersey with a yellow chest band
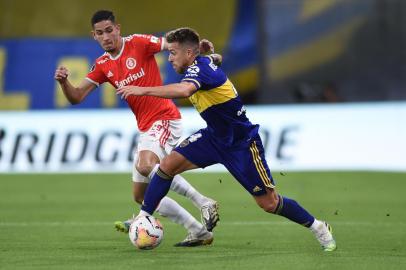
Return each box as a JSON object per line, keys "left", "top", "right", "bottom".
{"left": 182, "top": 56, "right": 258, "bottom": 147}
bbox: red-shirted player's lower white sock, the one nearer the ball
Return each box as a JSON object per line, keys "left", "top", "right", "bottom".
{"left": 156, "top": 197, "right": 206, "bottom": 235}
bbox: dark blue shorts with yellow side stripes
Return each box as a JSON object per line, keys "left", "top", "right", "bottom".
{"left": 174, "top": 129, "right": 275, "bottom": 196}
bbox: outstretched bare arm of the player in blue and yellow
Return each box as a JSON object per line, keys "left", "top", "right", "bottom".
{"left": 117, "top": 82, "right": 197, "bottom": 99}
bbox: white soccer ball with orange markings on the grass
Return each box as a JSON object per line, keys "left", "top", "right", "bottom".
{"left": 128, "top": 216, "right": 164, "bottom": 249}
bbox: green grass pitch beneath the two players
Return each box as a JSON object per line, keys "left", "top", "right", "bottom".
{"left": 0, "top": 172, "right": 406, "bottom": 270}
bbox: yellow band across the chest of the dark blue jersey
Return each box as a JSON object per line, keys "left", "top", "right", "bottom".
{"left": 188, "top": 79, "right": 237, "bottom": 113}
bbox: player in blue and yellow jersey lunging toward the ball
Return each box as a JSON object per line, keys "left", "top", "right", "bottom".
{"left": 117, "top": 28, "right": 336, "bottom": 251}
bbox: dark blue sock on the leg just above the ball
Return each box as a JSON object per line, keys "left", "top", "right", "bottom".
{"left": 141, "top": 168, "right": 173, "bottom": 215}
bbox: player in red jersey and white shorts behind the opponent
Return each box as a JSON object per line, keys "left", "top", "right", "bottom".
{"left": 55, "top": 10, "right": 219, "bottom": 246}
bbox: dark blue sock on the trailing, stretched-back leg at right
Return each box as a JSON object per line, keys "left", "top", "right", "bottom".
{"left": 275, "top": 195, "right": 314, "bottom": 227}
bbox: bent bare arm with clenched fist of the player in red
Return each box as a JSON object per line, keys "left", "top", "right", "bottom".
{"left": 55, "top": 67, "right": 96, "bottom": 105}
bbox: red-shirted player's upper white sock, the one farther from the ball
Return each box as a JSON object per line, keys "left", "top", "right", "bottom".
{"left": 171, "top": 174, "right": 209, "bottom": 209}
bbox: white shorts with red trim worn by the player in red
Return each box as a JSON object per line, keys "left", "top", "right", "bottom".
{"left": 132, "top": 119, "right": 182, "bottom": 183}
